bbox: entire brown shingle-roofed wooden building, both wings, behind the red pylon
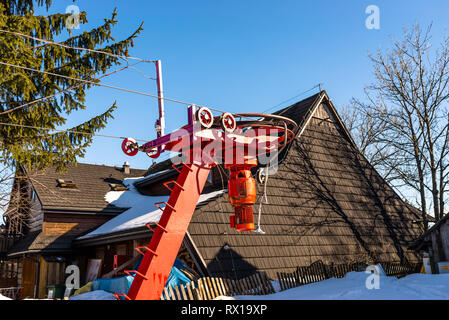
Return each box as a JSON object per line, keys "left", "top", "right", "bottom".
{"left": 1, "top": 91, "right": 421, "bottom": 295}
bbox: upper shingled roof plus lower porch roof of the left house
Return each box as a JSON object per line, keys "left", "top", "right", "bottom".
{"left": 8, "top": 163, "right": 145, "bottom": 257}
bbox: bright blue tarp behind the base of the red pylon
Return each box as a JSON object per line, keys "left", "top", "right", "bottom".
{"left": 92, "top": 258, "right": 191, "bottom": 293}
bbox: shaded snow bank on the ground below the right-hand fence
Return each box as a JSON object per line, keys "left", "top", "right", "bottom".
{"left": 235, "top": 272, "right": 449, "bottom": 300}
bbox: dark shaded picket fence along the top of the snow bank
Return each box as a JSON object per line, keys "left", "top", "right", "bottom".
{"left": 277, "top": 260, "right": 421, "bottom": 291}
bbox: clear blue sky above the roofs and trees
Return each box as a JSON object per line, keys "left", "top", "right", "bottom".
{"left": 38, "top": 0, "right": 449, "bottom": 168}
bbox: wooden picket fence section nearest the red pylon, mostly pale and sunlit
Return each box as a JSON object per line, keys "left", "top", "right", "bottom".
{"left": 161, "top": 273, "right": 275, "bottom": 300}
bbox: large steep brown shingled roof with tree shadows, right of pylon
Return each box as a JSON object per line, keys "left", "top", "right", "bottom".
{"left": 185, "top": 92, "right": 420, "bottom": 277}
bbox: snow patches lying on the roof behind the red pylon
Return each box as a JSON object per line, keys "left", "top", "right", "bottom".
{"left": 78, "top": 177, "right": 223, "bottom": 239}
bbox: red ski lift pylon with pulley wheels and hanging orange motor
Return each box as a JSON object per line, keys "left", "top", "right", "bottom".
{"left": 116, "top": 105, "right": 298, "bottom": 300}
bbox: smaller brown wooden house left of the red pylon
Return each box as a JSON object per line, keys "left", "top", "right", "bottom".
{"left": 0, "top": 163, "right": 145, "bottom": 298}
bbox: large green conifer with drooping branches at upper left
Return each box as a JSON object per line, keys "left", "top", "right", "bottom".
{"left": 0, "top": 0, "right": 142, "bottom": 169}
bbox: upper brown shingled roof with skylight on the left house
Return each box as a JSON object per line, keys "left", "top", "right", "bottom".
{"left": 29, "top": 163, "right": 145, "bottom": 213}
